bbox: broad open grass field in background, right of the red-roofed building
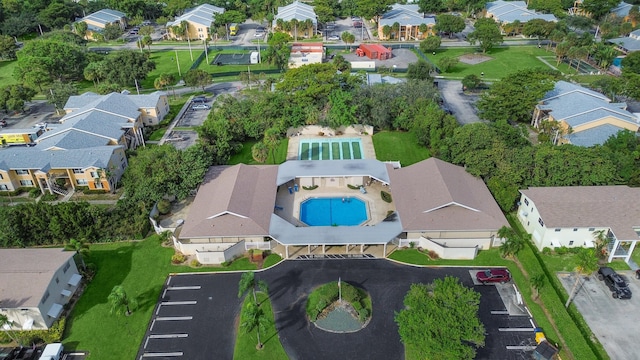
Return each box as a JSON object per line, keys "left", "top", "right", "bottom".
{"left": 427, "top": 46, "right": 575, "bottom": 80}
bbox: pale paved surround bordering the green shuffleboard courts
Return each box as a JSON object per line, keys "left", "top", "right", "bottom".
{"left": 287, "top": 125, "right": 376, "bottom": 161}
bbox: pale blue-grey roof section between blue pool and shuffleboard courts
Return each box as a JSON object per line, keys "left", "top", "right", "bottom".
{"left": 276, "top": 159, "right": 390, "bottom": 186}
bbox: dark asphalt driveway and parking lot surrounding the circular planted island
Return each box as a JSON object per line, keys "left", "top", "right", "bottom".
{"left": 137, "top": 259, "right": 535, "bottom": 359}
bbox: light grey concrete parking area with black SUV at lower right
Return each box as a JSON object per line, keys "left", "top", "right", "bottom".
{"left": 558, "top": 270, "right": 640, "bottom": 360}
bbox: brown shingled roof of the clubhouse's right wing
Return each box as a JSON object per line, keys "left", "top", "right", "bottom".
{"left": 390, "top": 158, "right": 508, "bottom": 231}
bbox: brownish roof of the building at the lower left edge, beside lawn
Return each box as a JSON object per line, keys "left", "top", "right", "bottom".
{"left": 0, "top": 249, "right": 74, "bottom": 308}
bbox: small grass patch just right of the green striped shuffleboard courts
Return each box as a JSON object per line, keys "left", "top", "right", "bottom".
{"left": 373, "top": 131, "right": 431, "bottom": 166}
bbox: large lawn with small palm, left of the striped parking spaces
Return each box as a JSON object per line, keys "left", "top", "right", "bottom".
{"left": 63, "top": 235, "right": 256, "bottom": 359}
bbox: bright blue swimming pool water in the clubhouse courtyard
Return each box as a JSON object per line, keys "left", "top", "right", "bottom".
{"left": 300, "top": 197, "right": 367, "bottom": 226}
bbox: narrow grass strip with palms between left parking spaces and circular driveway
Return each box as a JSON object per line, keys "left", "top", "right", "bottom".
{"left": 233, "top": 292, "right": 288, "bottom": 360}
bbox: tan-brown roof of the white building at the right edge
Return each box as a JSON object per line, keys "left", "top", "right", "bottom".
{"left": 520, "top": 185, "right": 640, "bottom": 240}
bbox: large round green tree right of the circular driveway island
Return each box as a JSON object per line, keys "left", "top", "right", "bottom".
{"left": 395, "top": 276, "right": 485, "bottom": 360}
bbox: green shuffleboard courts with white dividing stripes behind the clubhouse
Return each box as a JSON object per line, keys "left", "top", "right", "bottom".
{"left": 298, "top": 138, "right": 363, "bottom": 160}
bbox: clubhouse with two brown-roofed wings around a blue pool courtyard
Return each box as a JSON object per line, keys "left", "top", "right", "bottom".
{"left": 173, "top": 158, "right": 508, "bottom": 264}
